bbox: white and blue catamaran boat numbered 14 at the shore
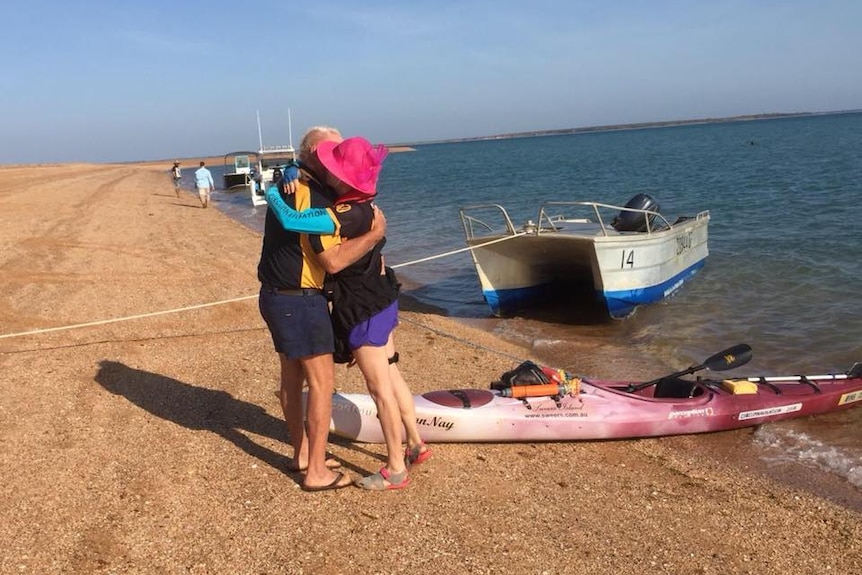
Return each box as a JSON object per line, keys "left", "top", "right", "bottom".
{"left": 461, "top": 194, "right": 709, "bottom": 318}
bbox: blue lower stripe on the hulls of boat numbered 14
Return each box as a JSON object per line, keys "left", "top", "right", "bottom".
{"left": 483, "top": 259, "right": 706, "bottom": 318}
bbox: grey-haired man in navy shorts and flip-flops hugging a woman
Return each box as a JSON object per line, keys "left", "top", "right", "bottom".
{"left": 258, "top": 127, "right": 386, "bottom": 491}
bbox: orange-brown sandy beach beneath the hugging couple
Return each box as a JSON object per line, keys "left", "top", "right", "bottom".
{"left": 0, "top": 163, "right": 862, "bottom": 575}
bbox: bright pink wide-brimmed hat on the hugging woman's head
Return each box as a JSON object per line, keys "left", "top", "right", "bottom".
{"left": 317, "top": 137, "right": 389, "bottom": 200}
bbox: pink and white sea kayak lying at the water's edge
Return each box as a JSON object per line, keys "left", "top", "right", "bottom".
{"left": 324, "top": 344, "right": 862, "bottom": 443}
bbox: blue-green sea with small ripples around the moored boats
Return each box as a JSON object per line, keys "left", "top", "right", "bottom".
{"left": 208, "top": 113, "right": 862, "bottom": 500}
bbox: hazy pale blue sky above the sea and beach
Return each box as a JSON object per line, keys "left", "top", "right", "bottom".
{"left": 0, "top": 0, "right": 862, "bottom": 164}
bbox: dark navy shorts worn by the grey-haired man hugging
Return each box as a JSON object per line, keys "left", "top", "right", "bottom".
{"left": 258, "top": 288, "right": 335, "bottom": 359}
